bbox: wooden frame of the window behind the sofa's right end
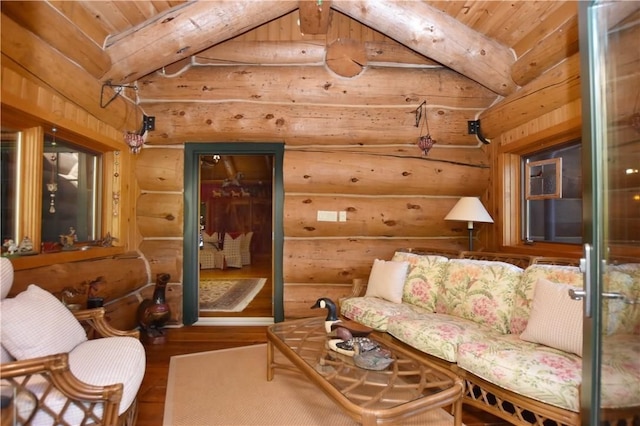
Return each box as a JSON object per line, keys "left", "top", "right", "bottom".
{"left": 495, "top": 120, "right": 582, "bottom": 257}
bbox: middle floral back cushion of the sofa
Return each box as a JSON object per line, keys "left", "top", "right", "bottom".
{"left": 436, "top": 259, "right": 523, "bottom": 333}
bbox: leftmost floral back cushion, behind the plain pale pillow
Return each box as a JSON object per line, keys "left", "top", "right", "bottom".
{"left": 393, "top": 252, "right": 449, "bottom": 312}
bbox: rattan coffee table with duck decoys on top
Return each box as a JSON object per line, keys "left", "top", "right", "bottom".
{"left": 267, "top": 317, "right": 464, "bottom": 426}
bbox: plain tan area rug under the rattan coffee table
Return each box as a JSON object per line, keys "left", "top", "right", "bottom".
{"left": 163, "top": 344, "right": 460, "bottom": 426}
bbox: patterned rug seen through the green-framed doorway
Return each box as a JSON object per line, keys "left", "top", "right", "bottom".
{"left": 198, "top": 278, "right": 267, "bottom": 312}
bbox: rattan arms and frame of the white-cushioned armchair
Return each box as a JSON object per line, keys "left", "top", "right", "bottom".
{"left": 0, "top": 308, "right": 140, "bottom": 426}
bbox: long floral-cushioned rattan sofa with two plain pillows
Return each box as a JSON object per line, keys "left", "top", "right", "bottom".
{"left": 340, "top": 249, "right": 640, "bottom": 425}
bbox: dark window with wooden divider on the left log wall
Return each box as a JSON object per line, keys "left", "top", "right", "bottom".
{"left": 0, "top": 121, "right": 106, "bottom": 253}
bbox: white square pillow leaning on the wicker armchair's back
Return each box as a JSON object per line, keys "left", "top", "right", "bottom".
{"left": 0, "top": 284, "right": 87, "bottom": 360}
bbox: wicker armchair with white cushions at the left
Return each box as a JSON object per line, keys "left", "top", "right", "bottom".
{"left": 0, "top": 258, "right": 145, "bottom": 426}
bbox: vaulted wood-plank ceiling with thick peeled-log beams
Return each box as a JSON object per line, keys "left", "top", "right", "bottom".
{"left": 2, "top": 0, "right": 577, "bottom": 96}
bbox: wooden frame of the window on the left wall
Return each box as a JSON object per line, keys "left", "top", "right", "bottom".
{"left": 2, "top": 104, "right": 128, "bottom": 270}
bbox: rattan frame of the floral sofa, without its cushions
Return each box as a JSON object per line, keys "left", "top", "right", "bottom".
{"left": 349, "top": 248, "right": 640, "bottom": 426}
